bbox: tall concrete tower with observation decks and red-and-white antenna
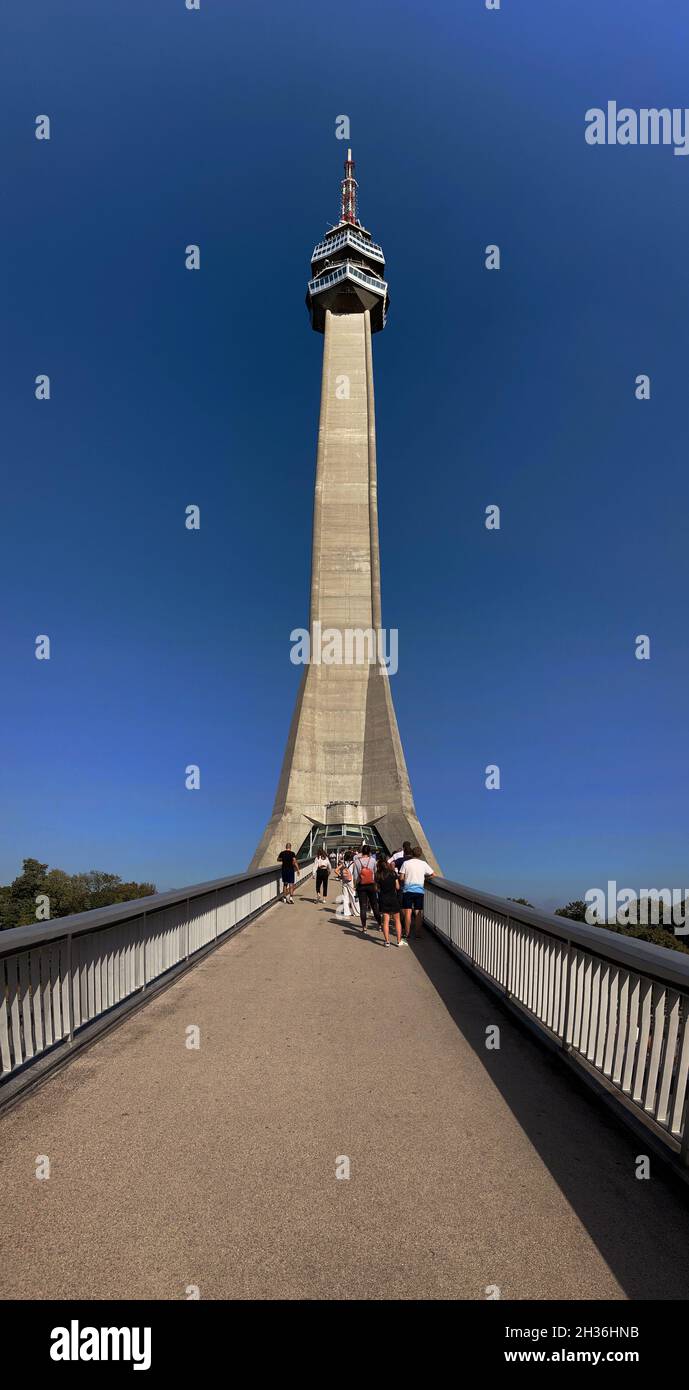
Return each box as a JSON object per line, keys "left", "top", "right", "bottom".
{"left": 251, "top": 150, "right": 435, "bottom": 869}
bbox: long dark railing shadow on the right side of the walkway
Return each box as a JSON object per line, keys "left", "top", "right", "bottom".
{"left": 411, "top": 930, "right": 689, "bottom": 1300}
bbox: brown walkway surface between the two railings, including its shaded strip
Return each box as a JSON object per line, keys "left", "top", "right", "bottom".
{"left": 0, "top": 885, "right": 689, "bottom": 1300}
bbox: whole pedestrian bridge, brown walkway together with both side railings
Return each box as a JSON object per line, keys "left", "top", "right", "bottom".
{"left": 0, "top": 870, "right": 689, "bottom": 1300}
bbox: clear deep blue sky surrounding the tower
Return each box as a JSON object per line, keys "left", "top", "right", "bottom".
{"left": 0, "top": 0, "right": 689, "bottom": 905}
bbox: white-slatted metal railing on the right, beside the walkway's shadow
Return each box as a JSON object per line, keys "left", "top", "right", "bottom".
{"left": 424, "top": 878, "right": 689, "bottom": 1165}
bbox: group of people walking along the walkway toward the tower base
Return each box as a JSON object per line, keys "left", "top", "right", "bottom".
{"left": 278, "top": 840, "right": 433, "bottom": 947}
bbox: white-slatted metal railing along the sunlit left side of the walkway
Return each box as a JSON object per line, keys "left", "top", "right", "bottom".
{"left": 0, "top": 866, "right": 313, "bottom": 1105}
